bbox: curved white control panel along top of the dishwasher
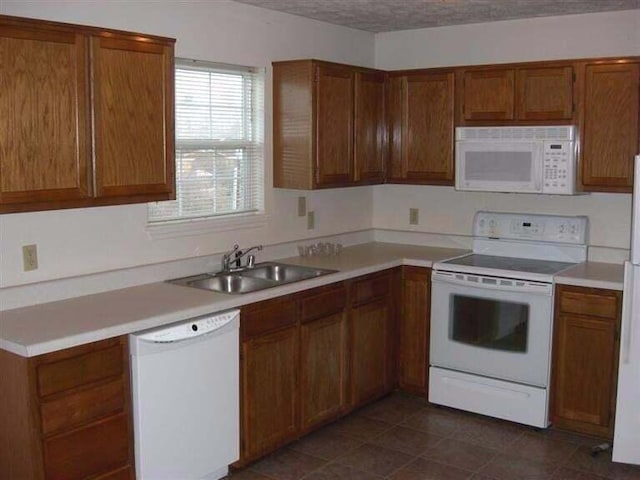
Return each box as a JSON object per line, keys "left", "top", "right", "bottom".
{"left": 137, "top": 310, "right": 240, "bottom": 343}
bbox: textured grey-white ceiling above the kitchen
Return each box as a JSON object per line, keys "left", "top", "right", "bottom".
{"left": 235, "top": 0, "right": 640, "bottom": 32}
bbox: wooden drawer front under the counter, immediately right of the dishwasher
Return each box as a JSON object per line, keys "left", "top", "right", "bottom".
{"left": 240, "top": 296, "right": 296, "bottom": 339}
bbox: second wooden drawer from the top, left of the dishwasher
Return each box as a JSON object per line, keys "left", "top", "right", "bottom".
{"left": 40, "top": 378, "right": 125, "bottom": 435}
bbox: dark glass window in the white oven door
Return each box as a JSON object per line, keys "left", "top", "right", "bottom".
{"left": 449, "top": 295, "right": 529, "bottom": 353}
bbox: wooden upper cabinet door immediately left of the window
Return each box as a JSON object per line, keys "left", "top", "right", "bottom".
{"left": 92, "top": 36, "right": 175, "bottom": 203}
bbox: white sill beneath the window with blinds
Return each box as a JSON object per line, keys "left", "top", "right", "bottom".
{"left": 146, "top": 212, "right": 269, "bottom": 240}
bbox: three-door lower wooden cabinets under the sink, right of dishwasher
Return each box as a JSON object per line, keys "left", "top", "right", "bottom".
{"left": 235, "top": 271, "right": 395, "bottom": 467}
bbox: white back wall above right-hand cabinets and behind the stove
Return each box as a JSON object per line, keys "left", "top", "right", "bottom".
{"left": 373, "top": 10, "right": 640, "bottom": 261}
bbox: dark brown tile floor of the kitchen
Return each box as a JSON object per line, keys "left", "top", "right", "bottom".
{"left": 230, "top": 393, "right": 640, "bottom": 480}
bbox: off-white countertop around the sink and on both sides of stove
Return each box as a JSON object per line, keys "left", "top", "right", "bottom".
{"left": 0, "top": 243, "right": 623, "bottom": 357}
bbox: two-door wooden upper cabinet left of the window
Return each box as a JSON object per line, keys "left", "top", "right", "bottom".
{"left": 0, "top": 16, "right": 174, "bottom": 213}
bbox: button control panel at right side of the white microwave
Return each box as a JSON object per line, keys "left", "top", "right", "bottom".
{"left": 542, "top": 141, "right": 576, "bottom": 195}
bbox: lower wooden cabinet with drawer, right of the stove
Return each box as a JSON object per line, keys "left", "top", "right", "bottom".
{"left": 551, "top": 285, "right": 622, "bottom": 438}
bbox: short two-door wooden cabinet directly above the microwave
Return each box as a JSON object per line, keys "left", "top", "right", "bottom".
{"left": 456, "top": 62, "right": 574, "bottom": 125}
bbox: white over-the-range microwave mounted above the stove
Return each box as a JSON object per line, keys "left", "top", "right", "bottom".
{"left": 456, "top": 125, "right": 578, "bottom": 195}
